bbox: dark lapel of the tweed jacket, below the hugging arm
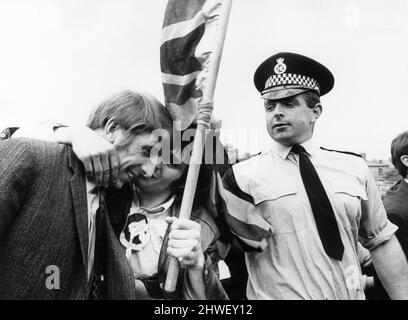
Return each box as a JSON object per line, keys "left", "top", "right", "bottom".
{"left": 68, "top": 147, "right": 89, "bottom": 274}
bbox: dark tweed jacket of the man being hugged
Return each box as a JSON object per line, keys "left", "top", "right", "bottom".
{"left": 0, "top": 139, "right": 137, "bottom": 299}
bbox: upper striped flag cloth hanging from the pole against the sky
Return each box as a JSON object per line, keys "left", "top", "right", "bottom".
{"left": 160, "top": 0, "right": 221, "bottom": 130}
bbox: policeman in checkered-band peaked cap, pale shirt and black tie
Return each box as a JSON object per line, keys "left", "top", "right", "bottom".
{"left": 222, "top": 52, "right": 408, "bottom": 299}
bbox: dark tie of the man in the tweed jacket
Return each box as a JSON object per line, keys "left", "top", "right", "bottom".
{"left": 89, "top": 190, "right": 107, "bottom": 300}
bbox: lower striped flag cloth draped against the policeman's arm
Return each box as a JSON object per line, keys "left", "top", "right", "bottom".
{"left": 198, "top": 134, "right": 272, "bottom": 251}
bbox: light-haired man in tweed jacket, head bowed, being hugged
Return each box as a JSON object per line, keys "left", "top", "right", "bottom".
{"left": 0, "top": 91, "right": 171, "bottom": 299}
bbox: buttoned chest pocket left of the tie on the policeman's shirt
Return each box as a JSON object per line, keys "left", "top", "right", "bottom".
{"left": 252, "top": 183, "right": 306, "bottom": 236}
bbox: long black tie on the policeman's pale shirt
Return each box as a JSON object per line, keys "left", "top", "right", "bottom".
{"left": 291, "top": 145, "right": 344, "bottom": 261}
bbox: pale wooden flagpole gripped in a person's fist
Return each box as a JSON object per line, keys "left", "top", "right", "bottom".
{"left": 164, "top": 0, "right": 232, "bottom": 299}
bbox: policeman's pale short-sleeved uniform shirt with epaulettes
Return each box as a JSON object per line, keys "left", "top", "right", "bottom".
{"left": 233, "top": 140, "right": 397, "bottom": 299}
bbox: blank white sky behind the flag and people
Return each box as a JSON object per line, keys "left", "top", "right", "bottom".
{"left": 0, "top": 0, "right": 408, "bottom": 159}
